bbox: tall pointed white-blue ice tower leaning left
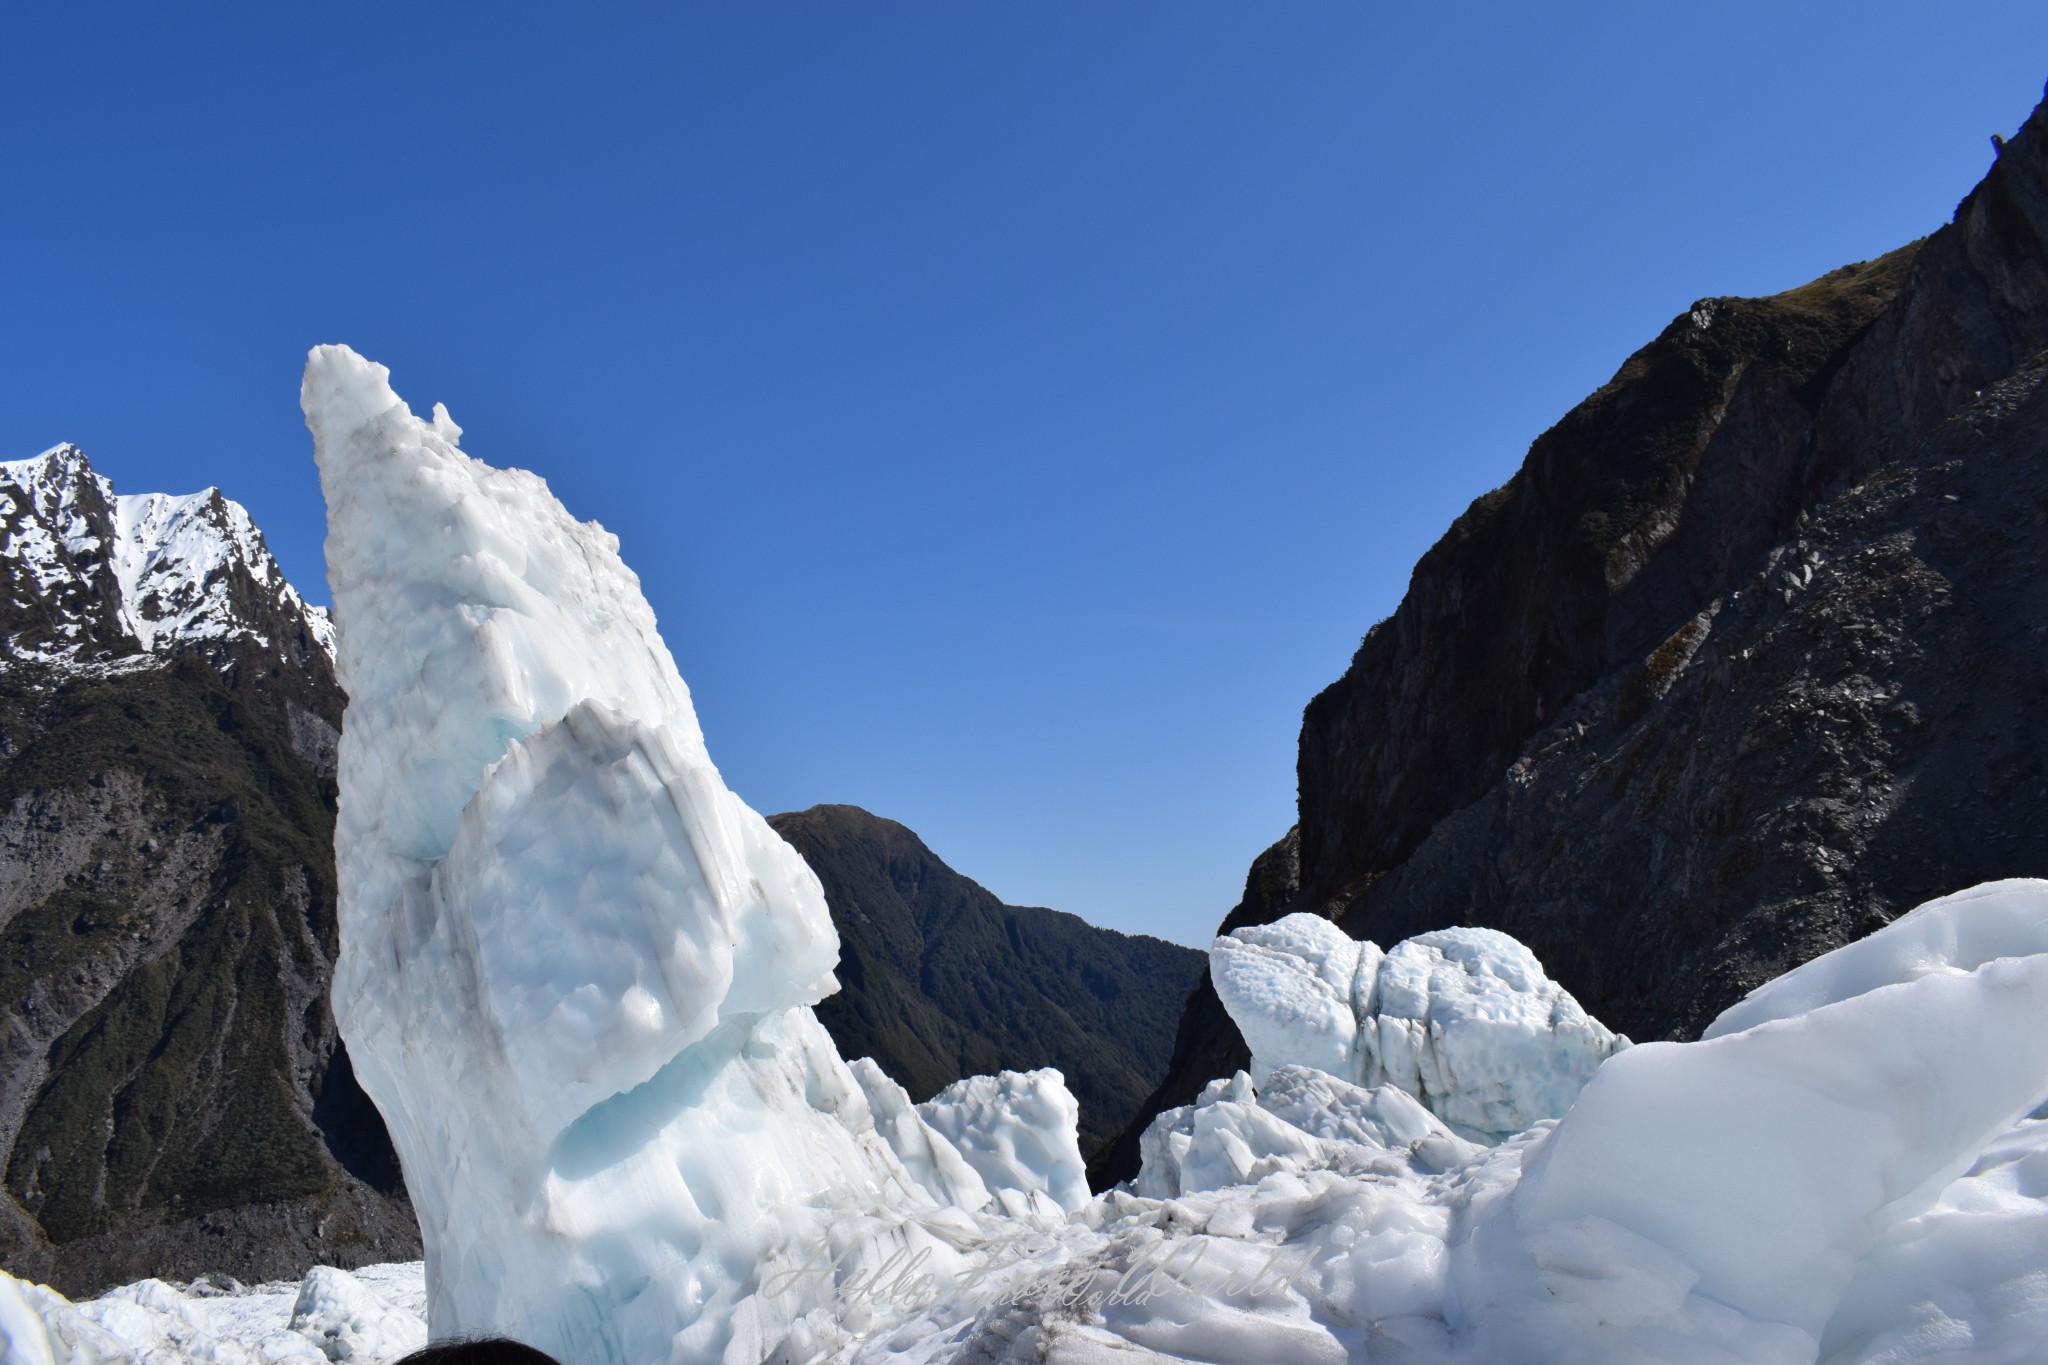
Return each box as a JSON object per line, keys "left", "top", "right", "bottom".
{"left": 301, "top": 346, "right": 967, "bottom": 1365}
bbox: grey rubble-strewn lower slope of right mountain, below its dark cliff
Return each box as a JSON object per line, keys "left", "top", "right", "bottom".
{"left": 1343, "top": 352, "right": 2048, "bottom": 1038}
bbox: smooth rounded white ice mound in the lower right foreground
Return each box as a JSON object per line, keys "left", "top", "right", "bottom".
{"left": 1495, "top": 949, "right": 2048, "bottom": 1363}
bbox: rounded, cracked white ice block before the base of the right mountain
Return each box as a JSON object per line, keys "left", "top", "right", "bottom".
{"left": 1208, "top": 915, "right": 1628, "bottom": 1142}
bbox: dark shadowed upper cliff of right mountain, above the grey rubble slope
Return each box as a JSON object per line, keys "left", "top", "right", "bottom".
{"left": 1298, "top": 248, "right": 1917, "bottom": 907}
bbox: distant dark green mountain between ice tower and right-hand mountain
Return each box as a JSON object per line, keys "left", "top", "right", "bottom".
{"left": 768, "top": 806, "right": 1204, "bottom": 1152}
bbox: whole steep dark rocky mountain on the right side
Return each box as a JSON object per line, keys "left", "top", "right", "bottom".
{"left": 1096, "top": 82, "right": 2048, "bottom": 1181}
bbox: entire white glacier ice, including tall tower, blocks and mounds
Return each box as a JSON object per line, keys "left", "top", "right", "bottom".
{"left": 0, "top": 348, "right": 2048, "bottom": 1365}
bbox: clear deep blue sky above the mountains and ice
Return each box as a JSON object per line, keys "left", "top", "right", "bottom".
{"left": 0, "top": 0, "right": 2048, "bottom": 943}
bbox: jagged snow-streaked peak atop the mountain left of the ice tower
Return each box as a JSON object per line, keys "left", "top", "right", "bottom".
{"left": 0, "top": 444, "right": 334, "bottom": 671}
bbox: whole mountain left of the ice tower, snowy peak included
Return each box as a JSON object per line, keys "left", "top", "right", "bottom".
{"left": 0, "top": 446, "right": 418, "bottom": 1293}
